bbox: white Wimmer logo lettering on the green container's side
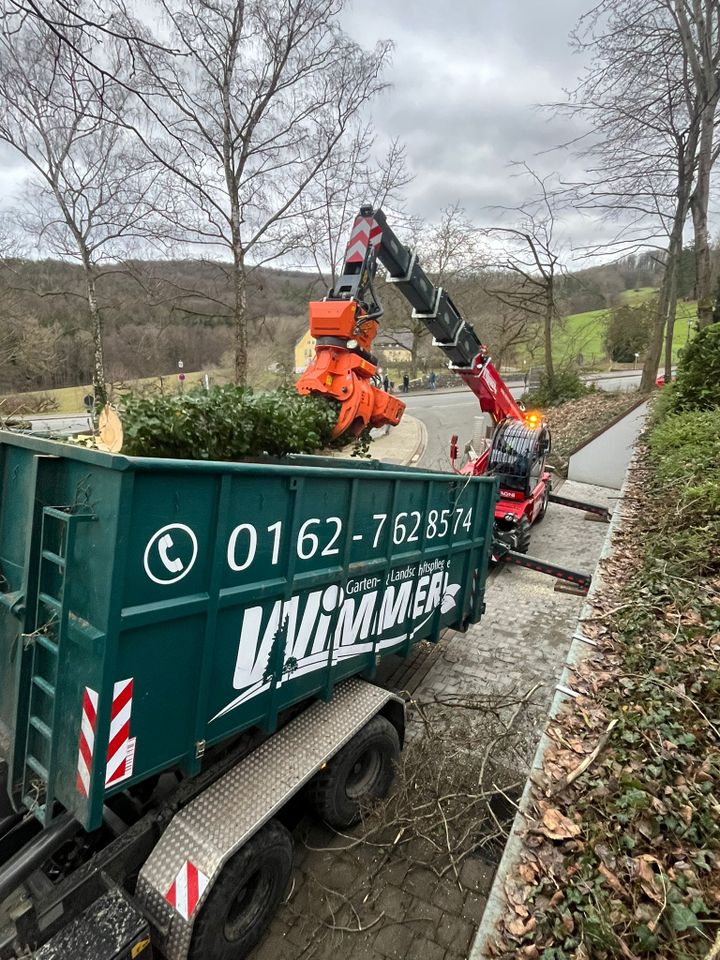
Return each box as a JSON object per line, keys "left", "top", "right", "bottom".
{"left": 212, "top": 559, "right": 460, "bottom": 720}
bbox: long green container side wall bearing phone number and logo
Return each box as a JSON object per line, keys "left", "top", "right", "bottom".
{"left": 116, "top": 466, "right": 495, "bottom": 768}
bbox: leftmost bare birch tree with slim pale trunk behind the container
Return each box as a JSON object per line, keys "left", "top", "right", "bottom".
{"left": 0, "top": 3, "right": 157, "bottom": 404}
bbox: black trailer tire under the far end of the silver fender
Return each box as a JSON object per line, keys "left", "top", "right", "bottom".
{"left": 307, "top": 716, "right": 400, "bottom": 829}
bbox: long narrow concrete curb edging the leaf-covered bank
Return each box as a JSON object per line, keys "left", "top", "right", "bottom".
{"left": 468, "top": 456, "right": 634, "bottom": 960}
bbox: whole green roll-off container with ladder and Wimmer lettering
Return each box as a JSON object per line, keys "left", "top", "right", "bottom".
{"left": 0, "top": 432, "right": 496, "bottom": 829}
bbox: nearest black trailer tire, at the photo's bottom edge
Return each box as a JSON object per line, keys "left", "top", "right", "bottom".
{"left": 188, "top": 820, "right": 293, "bottom": 960}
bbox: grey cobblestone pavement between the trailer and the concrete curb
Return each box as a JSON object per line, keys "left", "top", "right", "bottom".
{"left": 252, "top": 482, "right": 616, "bottom": 960}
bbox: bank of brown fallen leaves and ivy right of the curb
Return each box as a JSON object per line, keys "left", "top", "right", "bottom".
{"left": 493, "top": 408, "right": 720, "bottom": 960}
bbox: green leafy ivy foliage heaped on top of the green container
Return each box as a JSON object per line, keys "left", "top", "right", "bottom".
{"left": 122, "top": 385, "right": 337, "bottom": 460}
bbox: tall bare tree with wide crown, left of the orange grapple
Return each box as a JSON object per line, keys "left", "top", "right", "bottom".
{"left": 112, "top": 0, "right": 389, "bottom": 383}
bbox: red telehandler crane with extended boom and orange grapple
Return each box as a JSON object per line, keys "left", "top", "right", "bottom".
{"left": 297, "top": 206, "right": 607, "bottom": 581}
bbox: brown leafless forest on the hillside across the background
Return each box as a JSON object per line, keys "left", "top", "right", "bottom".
{"left": 0, "top": 251, "right": 694, "bottom": 393}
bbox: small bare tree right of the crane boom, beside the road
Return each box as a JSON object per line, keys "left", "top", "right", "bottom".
{"left": 483, "top": 164, "right": 565, "bottom": 383}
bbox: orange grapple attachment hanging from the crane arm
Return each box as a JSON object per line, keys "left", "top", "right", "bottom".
{"left": 296, "top": 300, "right": 405, "bottom": 437}
